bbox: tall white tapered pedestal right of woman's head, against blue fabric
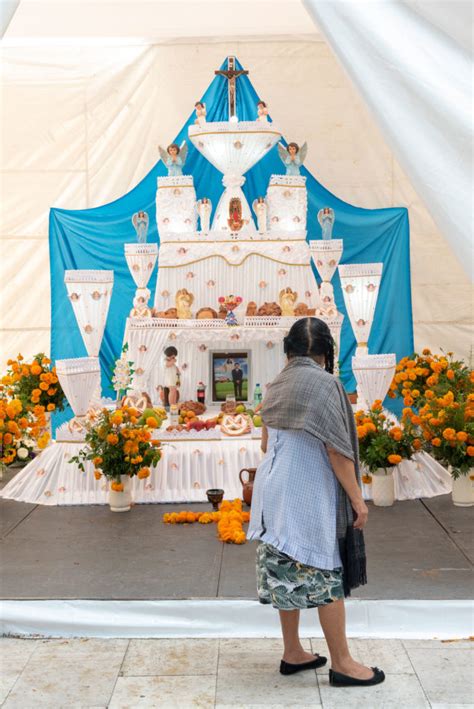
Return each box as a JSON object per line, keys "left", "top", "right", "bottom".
{"left": 339, "top": 263, "right": 383, "bottom": 357}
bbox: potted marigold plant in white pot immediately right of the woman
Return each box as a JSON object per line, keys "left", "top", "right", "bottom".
{"left": 355, "top": 401, "right": 414, "bottom": 507}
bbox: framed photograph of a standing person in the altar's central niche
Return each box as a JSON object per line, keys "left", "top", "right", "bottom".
{"left": 210, "top": 351, "right": 250, "bottom": 403}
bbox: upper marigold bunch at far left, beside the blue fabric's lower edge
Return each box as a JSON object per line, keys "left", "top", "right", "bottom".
{"left": 2, "top": 354, "right": 66, "bottom": 412}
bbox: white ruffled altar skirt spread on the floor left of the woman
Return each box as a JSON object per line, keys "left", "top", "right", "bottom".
{"left": 0, "top": 438, "right": 261, "bottom": 505}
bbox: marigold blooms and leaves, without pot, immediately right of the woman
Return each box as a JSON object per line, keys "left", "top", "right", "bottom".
{"left": 355, "top": 400, "right": 414, "bottom": 476}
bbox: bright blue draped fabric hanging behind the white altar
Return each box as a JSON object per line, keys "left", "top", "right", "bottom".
{"left": 49, "top": 61, "right": 413, "bottom": 425}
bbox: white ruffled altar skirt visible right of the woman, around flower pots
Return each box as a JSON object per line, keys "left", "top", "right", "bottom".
{"left": 362, "top": 452, "right": 453, "bottom": 500}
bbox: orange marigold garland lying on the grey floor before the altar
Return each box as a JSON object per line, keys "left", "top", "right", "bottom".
{"left": 163, "top": 498, "right": 250, "bottom": 544}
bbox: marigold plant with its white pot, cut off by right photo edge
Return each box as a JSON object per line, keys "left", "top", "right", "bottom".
{"left": 419, "top": 390, "right": 474, "bottom": 507}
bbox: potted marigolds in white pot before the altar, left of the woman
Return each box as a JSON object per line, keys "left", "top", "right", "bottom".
{"left": 70, "top": 406, "right": 161, "bottom": 512}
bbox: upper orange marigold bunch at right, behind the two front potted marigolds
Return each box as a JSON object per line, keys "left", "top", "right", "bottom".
{"left": 388, "top": 349, "right": 473, "bottom": 408}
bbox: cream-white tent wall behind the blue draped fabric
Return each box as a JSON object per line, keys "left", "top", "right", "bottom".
{"left": 0, "top": 41, "right": 471, "bottom": 359}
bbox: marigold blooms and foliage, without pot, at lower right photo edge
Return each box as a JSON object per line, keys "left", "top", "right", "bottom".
{"left": 403, "top": 385, "right": 474, "bottom": 479}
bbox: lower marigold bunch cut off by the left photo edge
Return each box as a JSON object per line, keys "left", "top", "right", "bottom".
{"left": 0, "top": 397, "right": 49, "bottom": 465}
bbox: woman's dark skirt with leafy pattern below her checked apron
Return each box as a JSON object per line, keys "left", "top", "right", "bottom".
{"left": 257, "top": 542, "right": 344, "bottom": 611}
